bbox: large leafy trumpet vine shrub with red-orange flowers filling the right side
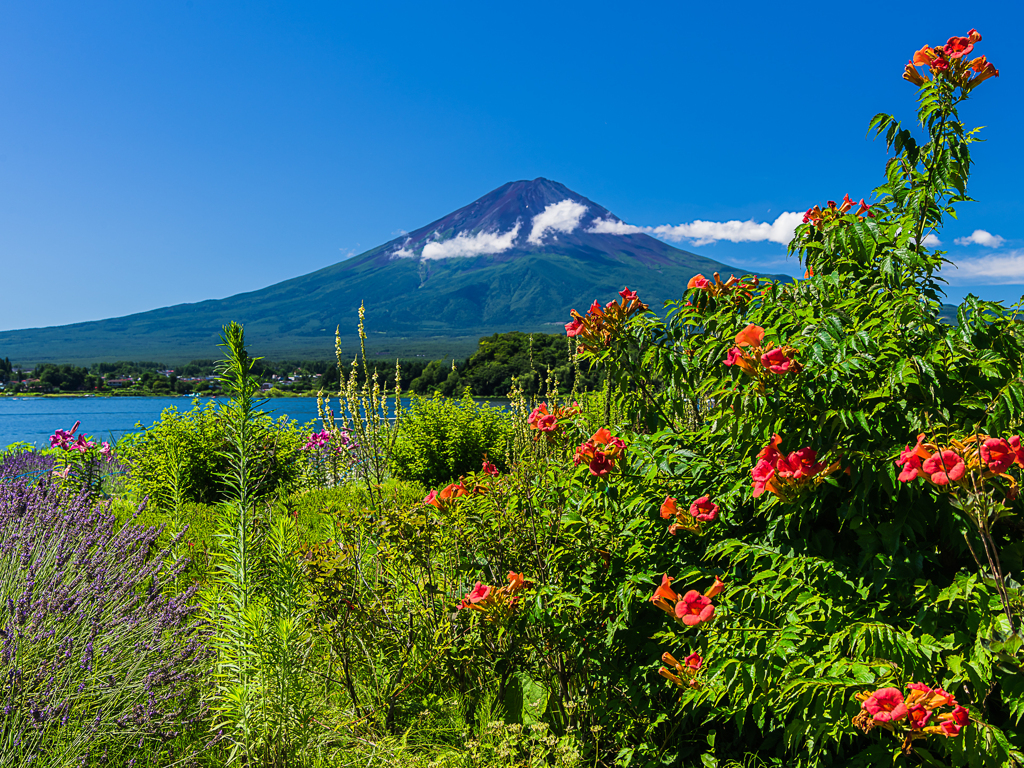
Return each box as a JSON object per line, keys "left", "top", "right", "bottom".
{"left": 552, "top": 30, "right": 1024, "bottom": 768}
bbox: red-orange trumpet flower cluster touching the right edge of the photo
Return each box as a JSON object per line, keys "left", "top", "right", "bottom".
{"left": 896, "top": 433, "right": 1024, "bottom": 488}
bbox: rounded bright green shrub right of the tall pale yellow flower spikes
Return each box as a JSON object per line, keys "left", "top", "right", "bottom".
{"left": 391, "top": 390, "right": 512, "bottom": 485}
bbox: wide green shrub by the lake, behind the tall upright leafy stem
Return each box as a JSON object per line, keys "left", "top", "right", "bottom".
{"left": 118, "top": 401, "right": 305, "bottom": 511}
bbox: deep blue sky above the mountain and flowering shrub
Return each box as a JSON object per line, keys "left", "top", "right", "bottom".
{"left": 0, "top": 0, "right": 1024, "bottom": 331}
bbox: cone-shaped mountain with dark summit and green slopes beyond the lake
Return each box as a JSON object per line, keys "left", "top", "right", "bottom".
{"left": 0, "top": 178, "right": 790, "bottom": 365}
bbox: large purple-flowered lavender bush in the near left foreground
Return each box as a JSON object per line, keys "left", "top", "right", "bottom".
{"left": 0, "top": 479, "right": 208, "bottom": 766}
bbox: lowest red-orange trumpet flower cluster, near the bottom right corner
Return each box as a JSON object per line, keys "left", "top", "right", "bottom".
{"left": 853, "top": 683, "right": 971, "bottom": 753}
